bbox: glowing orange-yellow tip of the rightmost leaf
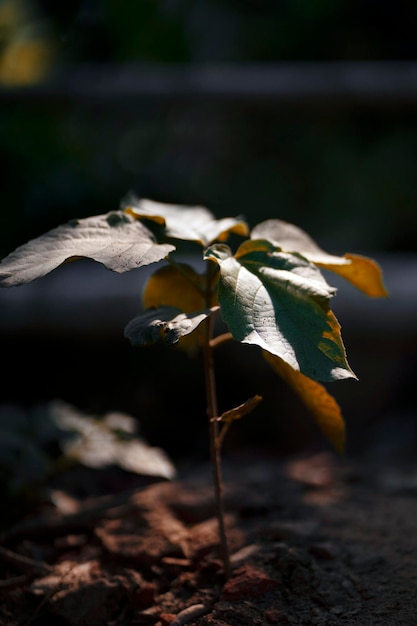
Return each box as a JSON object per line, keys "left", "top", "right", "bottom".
{"left": 317, "top": 253, "right": 389, "bottom": 298}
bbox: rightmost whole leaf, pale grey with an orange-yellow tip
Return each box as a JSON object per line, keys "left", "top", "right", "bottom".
{"left": 247, "top": 219, "right": 388, "bottom": 298}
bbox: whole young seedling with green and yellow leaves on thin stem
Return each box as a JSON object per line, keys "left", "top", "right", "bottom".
{"left": 0, "top": 195, "right": 387, "bottom": 577}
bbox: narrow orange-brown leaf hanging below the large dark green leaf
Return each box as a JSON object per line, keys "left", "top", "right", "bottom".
{"left": 264, "top": 351, "right": 345, "bottom": 452}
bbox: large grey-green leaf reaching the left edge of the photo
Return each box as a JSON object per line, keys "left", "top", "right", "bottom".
{"left": 0, "top": 211, "right": 175, "bottom": 287}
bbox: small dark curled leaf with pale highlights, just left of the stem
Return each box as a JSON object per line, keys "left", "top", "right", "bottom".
{"left": 124, "top": 306, "right": 219, "bottom": 346}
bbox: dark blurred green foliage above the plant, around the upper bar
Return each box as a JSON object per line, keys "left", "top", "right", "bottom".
{"left": 0, "top": 0, "right": 417, "bottom": 256}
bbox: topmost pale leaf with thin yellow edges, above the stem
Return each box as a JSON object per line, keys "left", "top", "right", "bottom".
{"left": 122, "top": 194, "right": 248, "bottom": 247}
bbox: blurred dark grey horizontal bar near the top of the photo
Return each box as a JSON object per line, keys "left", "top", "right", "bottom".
{"left": 0, "top": 61, "right": 417, "bottom": 107}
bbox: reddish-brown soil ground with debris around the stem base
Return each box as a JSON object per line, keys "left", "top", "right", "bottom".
{"left": 0, "top": 452, "right": 417, "bottom": 626}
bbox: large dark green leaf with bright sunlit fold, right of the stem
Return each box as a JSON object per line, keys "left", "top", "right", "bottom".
{"left": 205, "top": 240, "right": 356, "bottom": 381}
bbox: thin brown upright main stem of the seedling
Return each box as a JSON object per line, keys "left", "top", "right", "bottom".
{"left": 203, "top": 267, "right": 230, "bottom": 579}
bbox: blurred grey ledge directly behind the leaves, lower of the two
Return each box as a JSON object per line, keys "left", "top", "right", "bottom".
{"left": 0, "top": 253, "right": 417, "bottom": 340}
